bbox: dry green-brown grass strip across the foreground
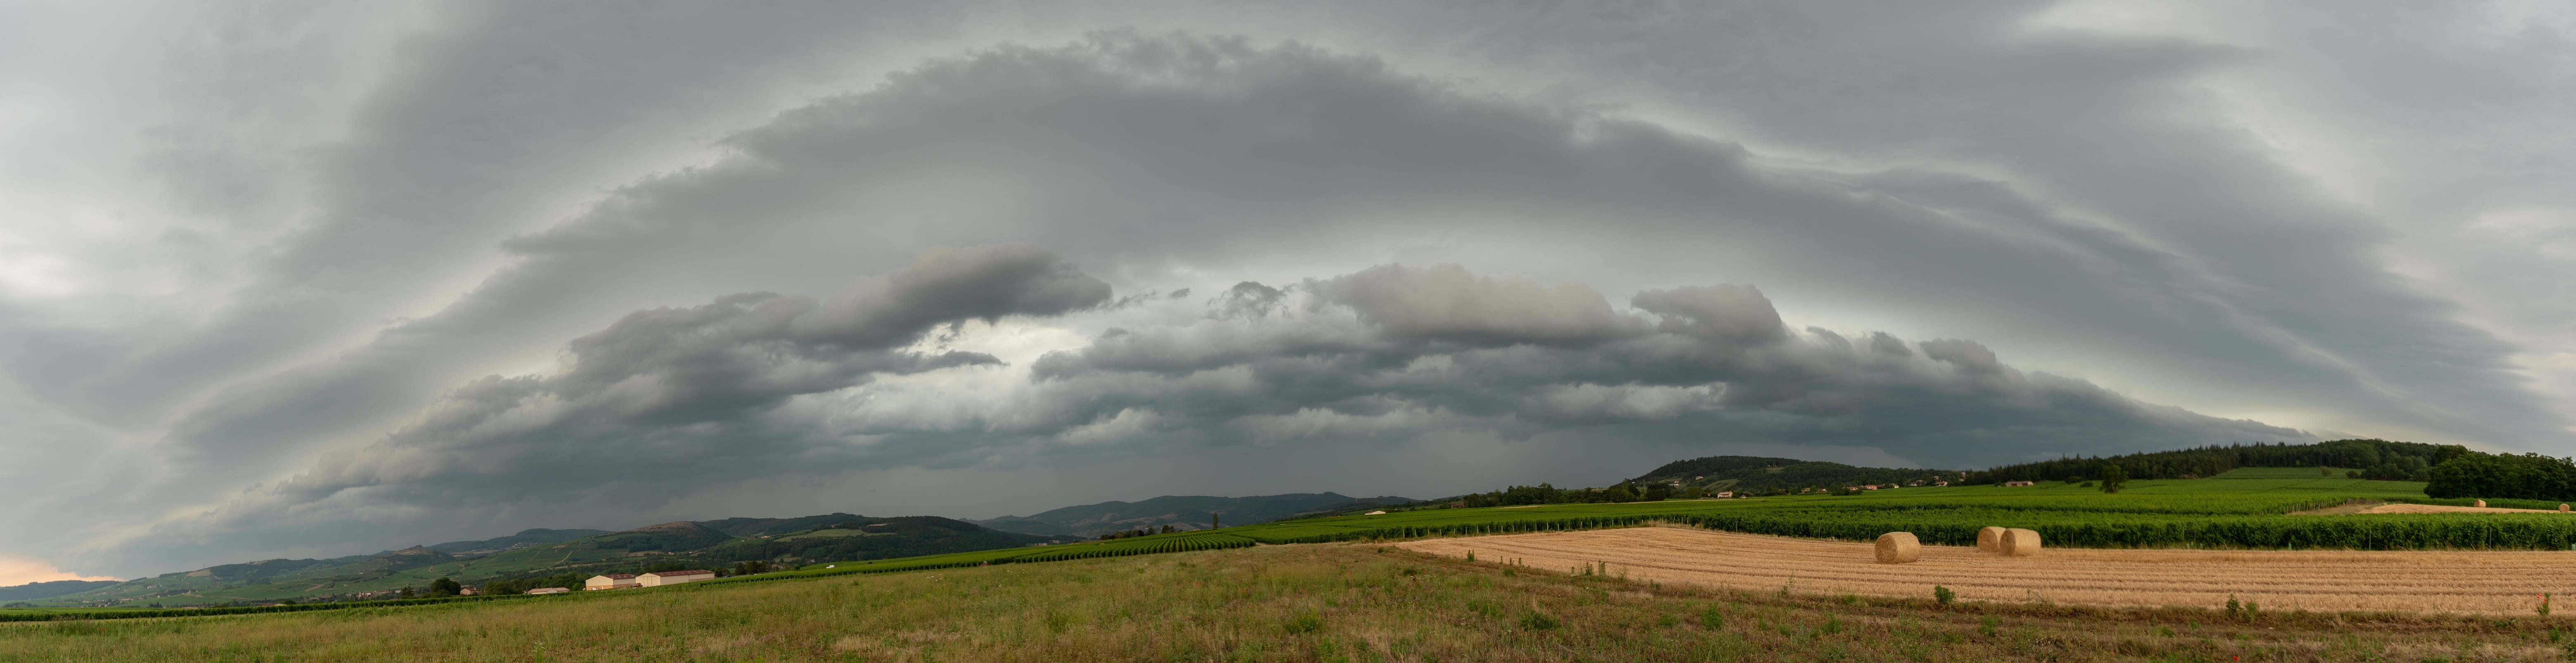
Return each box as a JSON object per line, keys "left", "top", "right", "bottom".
{"left": 0, "top": 544, "right": 2576, "bottom": 661}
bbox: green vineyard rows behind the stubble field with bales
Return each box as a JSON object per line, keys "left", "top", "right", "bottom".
{"left": 1226, "top": 480, "right": 2576, "bottom": 549}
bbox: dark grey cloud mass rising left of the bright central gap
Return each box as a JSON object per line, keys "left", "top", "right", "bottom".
{"left": 190, "top": 245, "right": 1110, "bottom": 534}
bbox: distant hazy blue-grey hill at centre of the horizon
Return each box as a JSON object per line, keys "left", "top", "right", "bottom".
{"left": 968, "top": 493, "right": 1409, "bottom": 537}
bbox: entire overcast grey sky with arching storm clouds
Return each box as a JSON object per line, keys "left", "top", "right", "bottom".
{"left": 0, "top": 0, "right": 2576, "bottom": 578}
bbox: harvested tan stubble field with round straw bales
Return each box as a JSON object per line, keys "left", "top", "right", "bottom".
{"left": 1401, "top": 526, "right": 2576, "bottom": 614}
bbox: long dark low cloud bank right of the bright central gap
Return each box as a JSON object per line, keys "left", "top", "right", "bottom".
{"left": 1023, "top": 266, "right": 2308, "bottom": 464}
